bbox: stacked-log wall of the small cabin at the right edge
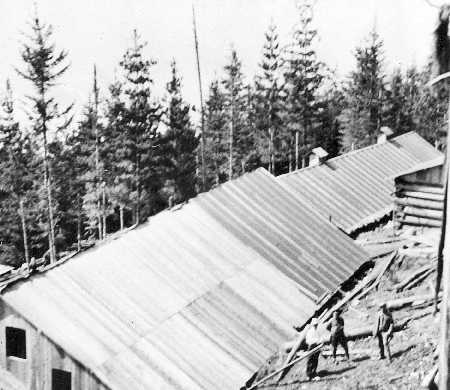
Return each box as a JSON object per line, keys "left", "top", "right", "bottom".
{"left": 394, "top": 165, "right": 444, "bottom": 230}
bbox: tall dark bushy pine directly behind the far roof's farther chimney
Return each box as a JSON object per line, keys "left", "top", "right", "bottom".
{"left": 341, "top": 31, "right": 386, "bottom": 151}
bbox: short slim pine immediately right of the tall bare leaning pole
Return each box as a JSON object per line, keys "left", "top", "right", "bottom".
{"left": 204, "top": 80, "right": 229, "bottom": 188}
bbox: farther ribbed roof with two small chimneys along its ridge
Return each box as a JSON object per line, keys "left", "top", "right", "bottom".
{"left": 277, "top": 132, "right": 442, "bottom": 234}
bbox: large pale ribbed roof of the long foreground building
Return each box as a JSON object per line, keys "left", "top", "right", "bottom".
{"left": 3, "top": 169, "right": 368, "bottom": 390}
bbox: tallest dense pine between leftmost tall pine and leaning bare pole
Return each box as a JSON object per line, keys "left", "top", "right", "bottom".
{"left": 120, "top": 31, "right": 161, "bottom": 223}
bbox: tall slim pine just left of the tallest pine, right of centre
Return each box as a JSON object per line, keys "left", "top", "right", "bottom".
{"left": 255, "top": 24, "right": 286, "bottom": 174}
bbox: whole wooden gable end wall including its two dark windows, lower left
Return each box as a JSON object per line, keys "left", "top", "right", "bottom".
{"left": 0, "top": 298, "right": 108, "bottom": 390}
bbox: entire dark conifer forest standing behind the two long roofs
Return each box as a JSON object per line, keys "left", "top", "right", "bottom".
{"left": 0, "top": 3, "right": 448, "bottom": 266}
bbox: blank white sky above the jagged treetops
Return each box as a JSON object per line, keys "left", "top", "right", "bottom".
{"left": 0, "top": 0, "right": 440, "bottom": 125}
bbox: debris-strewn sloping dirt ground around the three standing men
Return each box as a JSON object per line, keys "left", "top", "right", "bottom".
{"left": 251, "top": 227, "right": 439, "bottom": 390}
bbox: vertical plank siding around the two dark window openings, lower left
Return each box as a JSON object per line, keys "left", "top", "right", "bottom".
{"left": 0, "top": 299, "right": 108, "bottom": 390}
